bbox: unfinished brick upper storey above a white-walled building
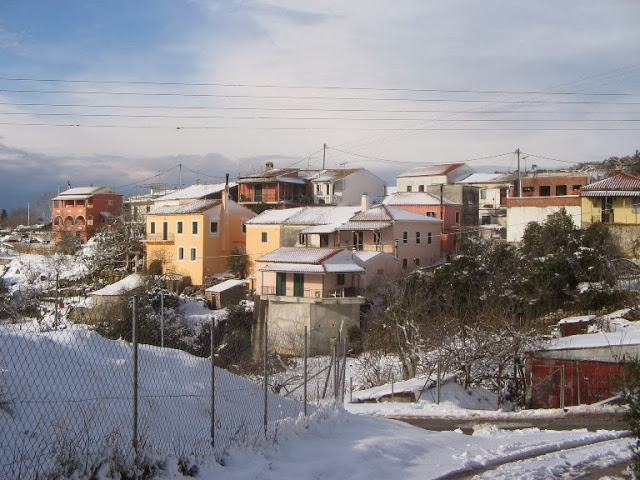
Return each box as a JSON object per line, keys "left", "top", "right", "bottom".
{"left": 506, "top": 172, "right": 590, "bottom": 242}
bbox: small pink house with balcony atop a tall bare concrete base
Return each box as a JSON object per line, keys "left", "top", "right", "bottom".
{"left": 256, "top": 247, "right": 365, "bottom": 355}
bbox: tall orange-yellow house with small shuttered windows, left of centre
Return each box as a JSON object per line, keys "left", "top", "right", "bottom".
{"left": 146, "top": 194, "right": 256, "bottom": 285}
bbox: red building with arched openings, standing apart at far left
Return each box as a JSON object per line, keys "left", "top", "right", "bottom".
{"left": 51, "top": 187, "right": 122, "bottom": 243}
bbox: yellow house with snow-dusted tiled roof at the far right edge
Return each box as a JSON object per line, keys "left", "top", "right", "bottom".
{"left": 580, "top": 173, "right": 640, "bottom": 226}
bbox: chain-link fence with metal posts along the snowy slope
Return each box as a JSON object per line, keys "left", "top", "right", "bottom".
{"left": 0, "top": 306, "right": 345, "bottom": 479}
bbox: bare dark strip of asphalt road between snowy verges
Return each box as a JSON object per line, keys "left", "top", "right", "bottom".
{"left": 386, "top": 413, "right": 629, "bottom": 435}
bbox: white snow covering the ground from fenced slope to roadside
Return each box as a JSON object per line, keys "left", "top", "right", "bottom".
{"left": 0, "top": 251, "right": 633, "bottom": 480}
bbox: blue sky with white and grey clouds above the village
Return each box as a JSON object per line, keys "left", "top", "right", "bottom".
{"left": 0, "top": 0, "right": 640, "bottom": 210}
